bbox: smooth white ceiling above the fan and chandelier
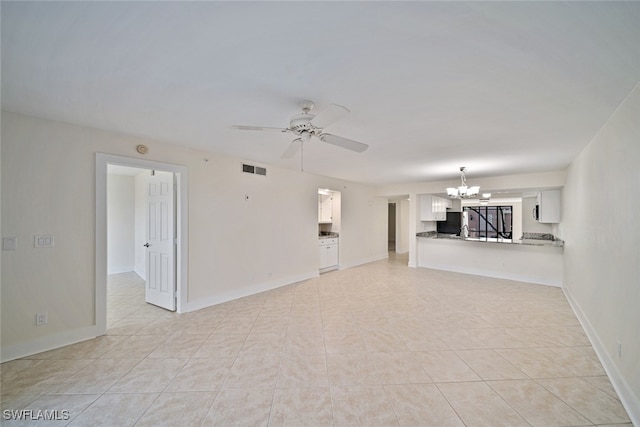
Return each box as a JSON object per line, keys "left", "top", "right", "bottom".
{"left": 1, "top": 1, "right": 640, "bottom": 185}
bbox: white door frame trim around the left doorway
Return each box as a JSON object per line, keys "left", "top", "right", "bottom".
{"left": 95, "top": 153, "right": 189, "bottom": 335}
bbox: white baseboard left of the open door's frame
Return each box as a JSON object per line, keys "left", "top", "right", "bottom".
{"left": 0, "top": 326, "right": 98, "bottom": 363}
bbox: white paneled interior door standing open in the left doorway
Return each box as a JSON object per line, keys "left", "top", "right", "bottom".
{"left": 145, "top": 171, "right": 176, "bottom": 311}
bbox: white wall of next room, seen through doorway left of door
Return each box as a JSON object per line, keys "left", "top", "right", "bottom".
{"left": 107, "top": 174, "right": 135, "bottom": 274}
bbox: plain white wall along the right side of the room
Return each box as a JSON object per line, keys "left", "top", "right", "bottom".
{"left": 559, "top": 82, "right": 640, "bottom": 425}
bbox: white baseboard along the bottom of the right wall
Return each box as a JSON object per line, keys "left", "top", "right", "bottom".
{"left": 562, "top": 288, "right": 640, "bottom": 426}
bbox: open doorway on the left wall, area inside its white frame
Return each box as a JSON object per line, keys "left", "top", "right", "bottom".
{"left": 107, "top": 164, "right": 175, "bottom": 330}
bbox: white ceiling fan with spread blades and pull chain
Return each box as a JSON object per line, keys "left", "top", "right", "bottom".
{"left": 233, "top": 100, "right": 369, "bottom": 159}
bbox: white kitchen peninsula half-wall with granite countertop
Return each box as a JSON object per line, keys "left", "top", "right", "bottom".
{"left": 416, "top": 231, "right": 564, "bottom": 286}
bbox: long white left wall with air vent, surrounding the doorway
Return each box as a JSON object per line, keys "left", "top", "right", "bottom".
{"left": 1, "top": 112, "right": 387, "bottom": 360}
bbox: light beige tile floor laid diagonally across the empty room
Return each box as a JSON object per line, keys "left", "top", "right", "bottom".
{"left": 1, "top": 253, "right": 631, "bottom": 427}
